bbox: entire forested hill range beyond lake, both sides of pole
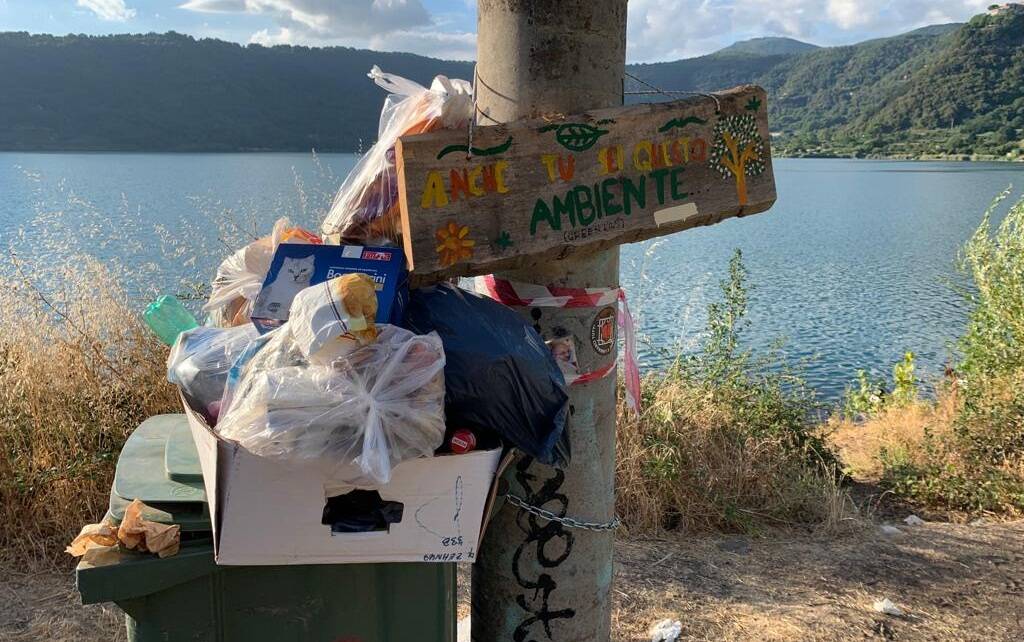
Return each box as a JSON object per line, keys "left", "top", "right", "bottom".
{"left": 0, "top": 5, "right": 1024, "bottom": 158}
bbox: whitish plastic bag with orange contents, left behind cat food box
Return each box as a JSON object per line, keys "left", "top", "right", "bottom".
{"left": 203, "top": 218, "right": 323, "bottom": 328}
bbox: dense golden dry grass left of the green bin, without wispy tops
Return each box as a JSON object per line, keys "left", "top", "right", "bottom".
{"left": 0, "top": 258, "right": 176, "bottom": 559}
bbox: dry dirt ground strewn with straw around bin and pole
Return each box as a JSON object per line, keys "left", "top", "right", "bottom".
{"left": 0, "top": 520, "right": 1024, "bottom": 642}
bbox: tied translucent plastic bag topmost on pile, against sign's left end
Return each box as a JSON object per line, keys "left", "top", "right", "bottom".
{"left": 323, "top": 66, "right": 473, "bottom": 245}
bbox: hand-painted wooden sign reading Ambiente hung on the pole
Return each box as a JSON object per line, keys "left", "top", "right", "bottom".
{"left": 396, "top": 86, "right": 775, "bottom": 282}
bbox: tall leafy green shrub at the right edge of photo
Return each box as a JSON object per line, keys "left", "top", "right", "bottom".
{"left": 882, "top": 195, "right": 1024, "bottom": 513}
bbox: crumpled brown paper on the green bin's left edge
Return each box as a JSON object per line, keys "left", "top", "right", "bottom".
{"left": 66, "top": 500, "right": 181, "bottom": 558}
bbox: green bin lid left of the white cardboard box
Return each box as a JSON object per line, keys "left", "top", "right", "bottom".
{"left": 110, "top": 415, "right": 210, "bottom": 531}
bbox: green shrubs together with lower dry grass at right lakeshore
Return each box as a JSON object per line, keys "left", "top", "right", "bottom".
{"left": 834, "top": 195, "right": 1024, "bottom": 515}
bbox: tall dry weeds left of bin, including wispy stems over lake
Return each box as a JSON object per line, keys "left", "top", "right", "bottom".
{"left": 0, "top": 155, "right": 338, "bottom": 559}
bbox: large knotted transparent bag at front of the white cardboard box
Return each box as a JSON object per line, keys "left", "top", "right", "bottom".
{"left": 217, "top": 324, "right": 444, "bottom": 484}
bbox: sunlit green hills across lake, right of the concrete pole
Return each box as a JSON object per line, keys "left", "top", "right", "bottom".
{"left": 630, "top": 5, "right": 1024, "bottom": 159}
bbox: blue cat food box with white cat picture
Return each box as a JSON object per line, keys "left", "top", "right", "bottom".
{"left": 252, "top": 243, "right": 409, "bottom": 333}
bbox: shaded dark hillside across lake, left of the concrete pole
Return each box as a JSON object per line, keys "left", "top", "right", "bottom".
{"left": 0, "top": 32, "right": 472, "bottom": 152}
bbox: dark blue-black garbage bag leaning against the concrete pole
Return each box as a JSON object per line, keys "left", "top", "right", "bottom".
{"left": 404, "top": 284, "right": 569, "bottom": 467}
